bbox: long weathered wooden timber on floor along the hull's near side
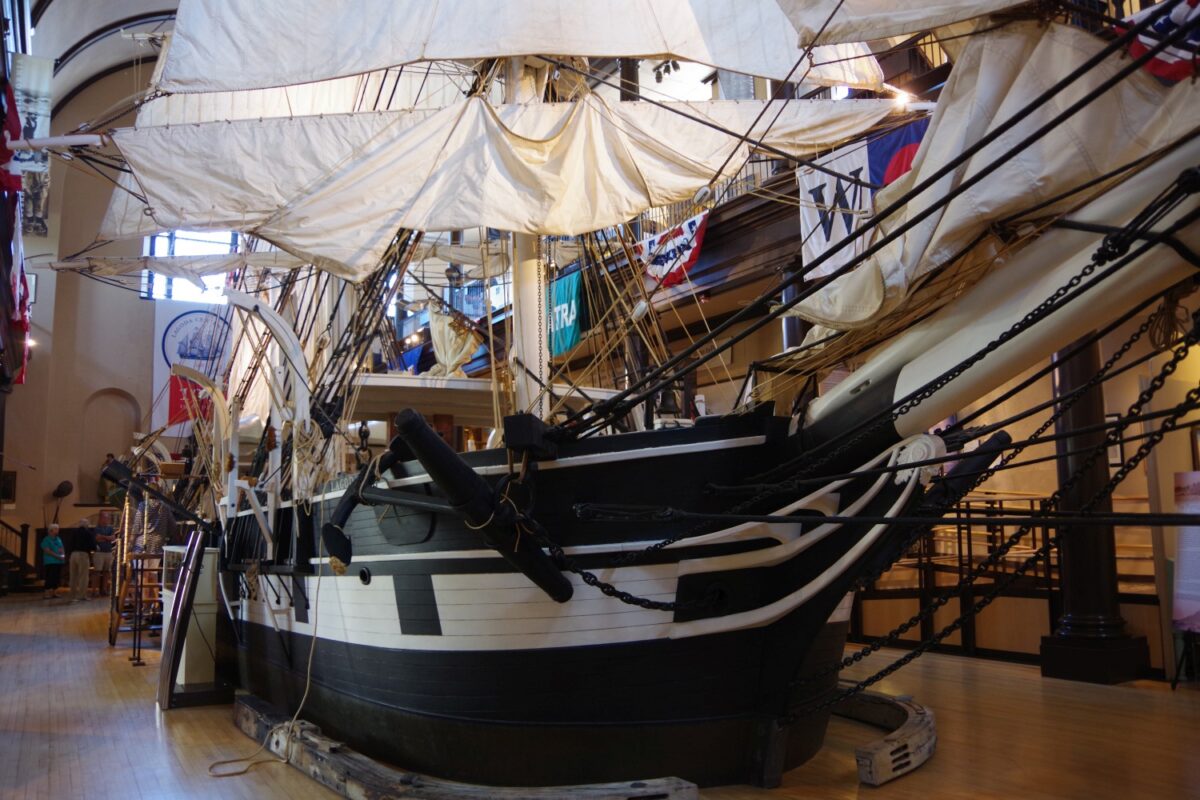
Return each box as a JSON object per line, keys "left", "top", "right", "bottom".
{"left": 233, "top": 694, "right": 700, "bottom": 800}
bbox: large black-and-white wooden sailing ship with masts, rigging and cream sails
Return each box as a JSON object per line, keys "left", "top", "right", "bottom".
{"left": 44, "top": 0, "right": 1200, "bottom": 786}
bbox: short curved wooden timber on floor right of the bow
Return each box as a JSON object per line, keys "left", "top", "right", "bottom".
{"left": 833, "top": 681, "right": 937, "bottom": 786}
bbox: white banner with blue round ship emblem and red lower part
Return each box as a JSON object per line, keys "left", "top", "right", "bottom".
{"left": 151, "top": 300, "right": 232, "bottom": 437}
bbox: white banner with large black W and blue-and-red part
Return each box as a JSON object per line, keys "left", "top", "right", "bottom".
{"left": 796, "top": 118, "right": 929, "bottom": 279}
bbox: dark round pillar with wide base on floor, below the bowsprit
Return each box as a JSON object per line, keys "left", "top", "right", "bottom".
{"left": 1042, "top": 342, "right": 1150, "bottom": 684}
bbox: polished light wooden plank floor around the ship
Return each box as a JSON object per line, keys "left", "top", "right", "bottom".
{"left": 0, "top": 595, "right": 1200, "bottom": 800}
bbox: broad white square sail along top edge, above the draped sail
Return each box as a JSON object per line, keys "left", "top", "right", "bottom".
{"left": 160, "top": 0, "right": 883, "bottom": 92}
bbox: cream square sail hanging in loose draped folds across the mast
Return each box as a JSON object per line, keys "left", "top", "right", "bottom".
{"left": 101, "top": 95, "right": 895, "bottom": 279}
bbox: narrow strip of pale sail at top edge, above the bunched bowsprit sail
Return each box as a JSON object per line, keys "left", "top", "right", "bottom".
{"left": 778, "top": 0, "right": 1022, "bottom": 47}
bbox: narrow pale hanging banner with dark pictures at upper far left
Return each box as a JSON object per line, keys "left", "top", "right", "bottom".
{"left": 12, "top": 53, "right": 54, "bottom": 236}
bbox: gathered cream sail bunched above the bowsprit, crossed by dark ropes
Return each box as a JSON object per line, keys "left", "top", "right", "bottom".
{"left": 798, "top": 22, "right": 1200, "bottom": 330}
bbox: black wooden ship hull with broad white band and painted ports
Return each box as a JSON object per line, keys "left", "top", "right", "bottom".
{"left": 226, "top": 417, "right": 920, "bottom": 786}
